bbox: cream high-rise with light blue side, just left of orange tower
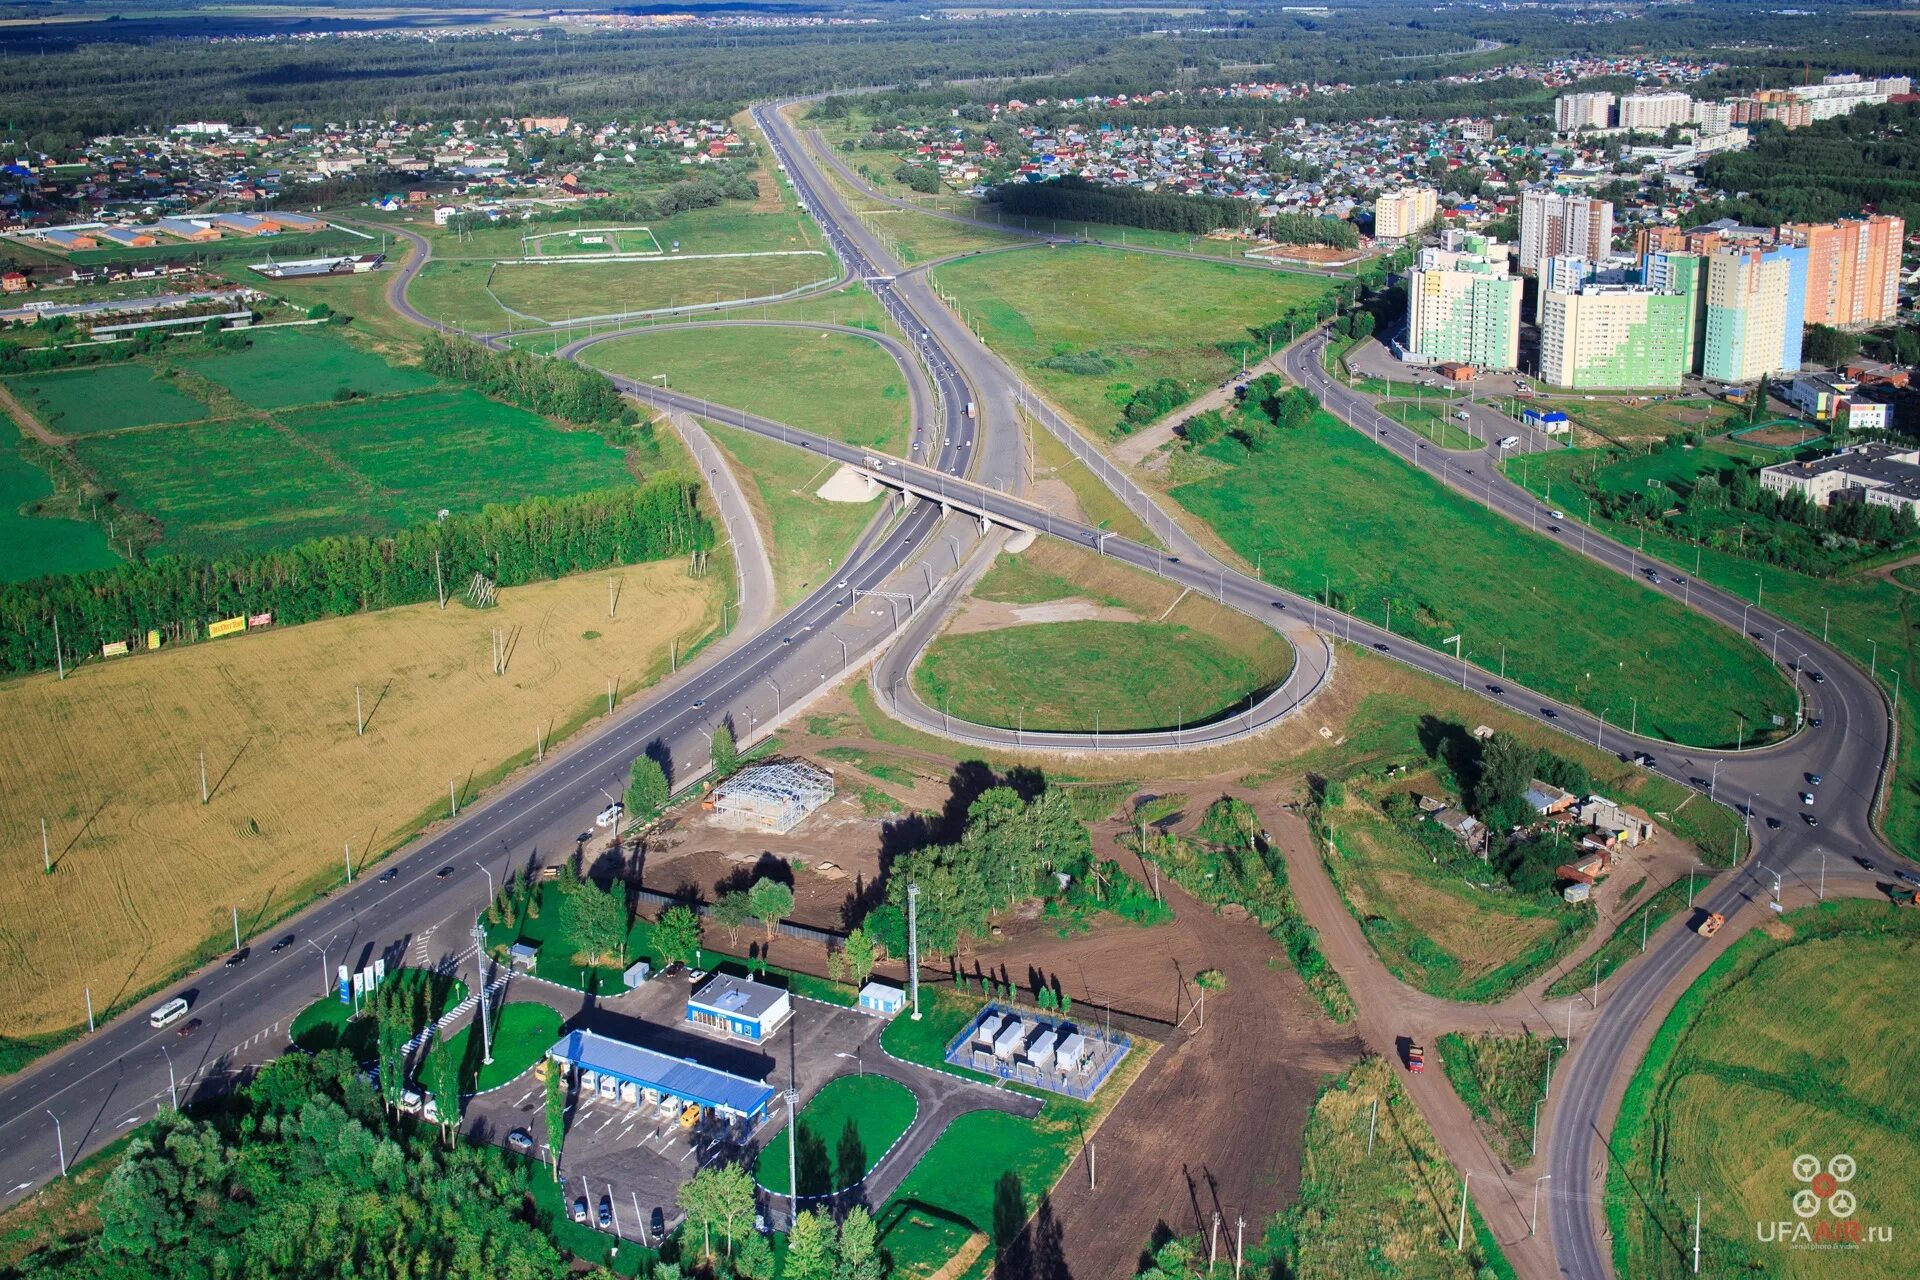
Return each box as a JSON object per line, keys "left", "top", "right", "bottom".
{"left": 1699, "top": 244, "right": 1807, "bottom": 382}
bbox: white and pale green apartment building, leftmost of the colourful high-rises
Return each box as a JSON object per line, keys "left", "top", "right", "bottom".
{"left": 1402, "top": 236, "right": 1523, "bottom": 368}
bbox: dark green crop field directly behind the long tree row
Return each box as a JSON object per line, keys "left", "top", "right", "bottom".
{"left": 75, "top": 388, "right": 628, "bottom": 555}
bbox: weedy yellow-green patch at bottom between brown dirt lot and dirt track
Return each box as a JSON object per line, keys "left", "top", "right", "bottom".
{"left": 1265, "top": 1057, "right": 1513, "bottom": 1280}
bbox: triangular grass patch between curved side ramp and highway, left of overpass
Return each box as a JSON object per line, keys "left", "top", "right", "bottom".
{"left": 707, "top": 422, "right": 879, "bottom": 608}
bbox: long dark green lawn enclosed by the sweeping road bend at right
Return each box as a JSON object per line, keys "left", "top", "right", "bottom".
{"left": 1173, "top": 415, "right": 1793, "bottom": 747}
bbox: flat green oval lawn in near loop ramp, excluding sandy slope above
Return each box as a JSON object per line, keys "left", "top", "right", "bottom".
{"left": 914, "top": 622, "right": 1273, "bottom": 733}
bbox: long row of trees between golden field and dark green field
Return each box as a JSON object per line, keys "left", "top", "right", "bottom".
{"left": 0, "top": 472, "right": 714, "bottom": 676}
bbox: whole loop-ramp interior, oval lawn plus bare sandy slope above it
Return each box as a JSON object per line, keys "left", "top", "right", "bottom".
{"left": 914, "top": 541, "right": 1292, "bottom": 731}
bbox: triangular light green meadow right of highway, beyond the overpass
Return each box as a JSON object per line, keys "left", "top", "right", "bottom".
{"left": 933, "top": 246, "right": 1329, "bottom": 432}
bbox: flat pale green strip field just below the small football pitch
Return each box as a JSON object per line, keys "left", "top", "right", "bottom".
{"left": 487, "top": 253, "right": 835, "bottom": 320}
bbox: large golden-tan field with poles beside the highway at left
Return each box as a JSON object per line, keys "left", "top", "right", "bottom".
{"left": 0, "top": 564, "right": 726, "bottom": 1038}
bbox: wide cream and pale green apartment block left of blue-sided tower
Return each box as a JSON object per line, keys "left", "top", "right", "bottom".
{"left": 1540, "top": 284, "right": 1693, "bottom": 390}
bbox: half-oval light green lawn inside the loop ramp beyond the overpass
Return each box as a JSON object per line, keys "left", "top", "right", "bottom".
{"left": 588, "top": 326, "right": 910, "bottom": 453}
